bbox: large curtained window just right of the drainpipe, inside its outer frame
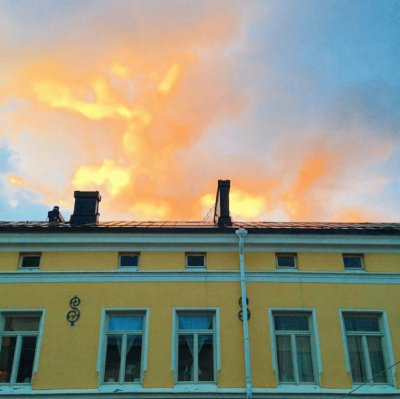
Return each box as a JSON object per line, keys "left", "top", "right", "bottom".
{"left": 273, "top": 312, "right": 316, "bottom": 384}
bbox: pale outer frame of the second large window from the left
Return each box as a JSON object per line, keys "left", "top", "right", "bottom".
{"left": 96, "top": 308, "right": 150, "bottom": 386}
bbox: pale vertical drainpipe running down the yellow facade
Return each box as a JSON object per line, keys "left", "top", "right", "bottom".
{"left": 236, "top": 229, "right": 252, "bottom": 399}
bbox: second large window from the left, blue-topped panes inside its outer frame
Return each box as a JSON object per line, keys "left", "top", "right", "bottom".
{"left": 103, "top": 312, "right": 145, "bottom": 384}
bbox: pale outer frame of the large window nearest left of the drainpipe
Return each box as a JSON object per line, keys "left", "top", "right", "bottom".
{"left": 171, "top": 307, "right": 221, "bottom": 386}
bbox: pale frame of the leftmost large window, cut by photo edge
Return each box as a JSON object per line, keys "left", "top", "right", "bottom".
{"left": 0, "top": 309, "right": 46, "bottom": 387}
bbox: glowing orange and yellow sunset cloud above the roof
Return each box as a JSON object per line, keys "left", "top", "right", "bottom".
{"left": 0, "top": 2, "right": 394, "bottom": 220}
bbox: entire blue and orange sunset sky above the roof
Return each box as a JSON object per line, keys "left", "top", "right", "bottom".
{"left": 0, "top": 0, "right": 400, "bottom": 222}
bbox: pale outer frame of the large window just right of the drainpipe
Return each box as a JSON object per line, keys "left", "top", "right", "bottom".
{"left": 268, "top": 308, "right": 323, "bottom": 386}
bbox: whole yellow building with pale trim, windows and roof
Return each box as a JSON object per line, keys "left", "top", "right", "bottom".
{"left": 0, "top": 185, "right": 400, "bottom": 399}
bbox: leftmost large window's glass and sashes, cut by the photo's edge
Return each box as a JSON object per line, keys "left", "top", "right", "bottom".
{"left": 0, "top": 312, "right": 41, "bottom": 385}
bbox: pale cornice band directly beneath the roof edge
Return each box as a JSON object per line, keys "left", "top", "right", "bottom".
{"left": 0, "top": 233, "right": 400, "bottom": 253}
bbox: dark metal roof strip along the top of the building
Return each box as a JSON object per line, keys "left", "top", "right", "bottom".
{"left": 0, "top": 221, "right": 400, "bottom": 235}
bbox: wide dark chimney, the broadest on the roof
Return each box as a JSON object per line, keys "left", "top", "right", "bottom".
{"left": 70, "top": 191, "right": 101, "bottom": 224}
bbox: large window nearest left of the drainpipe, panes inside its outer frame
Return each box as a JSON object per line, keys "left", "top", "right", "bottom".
{"left": 176, "top": 312, "right": 215, "bottom": 384}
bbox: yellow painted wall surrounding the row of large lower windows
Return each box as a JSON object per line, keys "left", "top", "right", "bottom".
{"left": 0, "top": 282, "right": 400, "bottom": 389}
